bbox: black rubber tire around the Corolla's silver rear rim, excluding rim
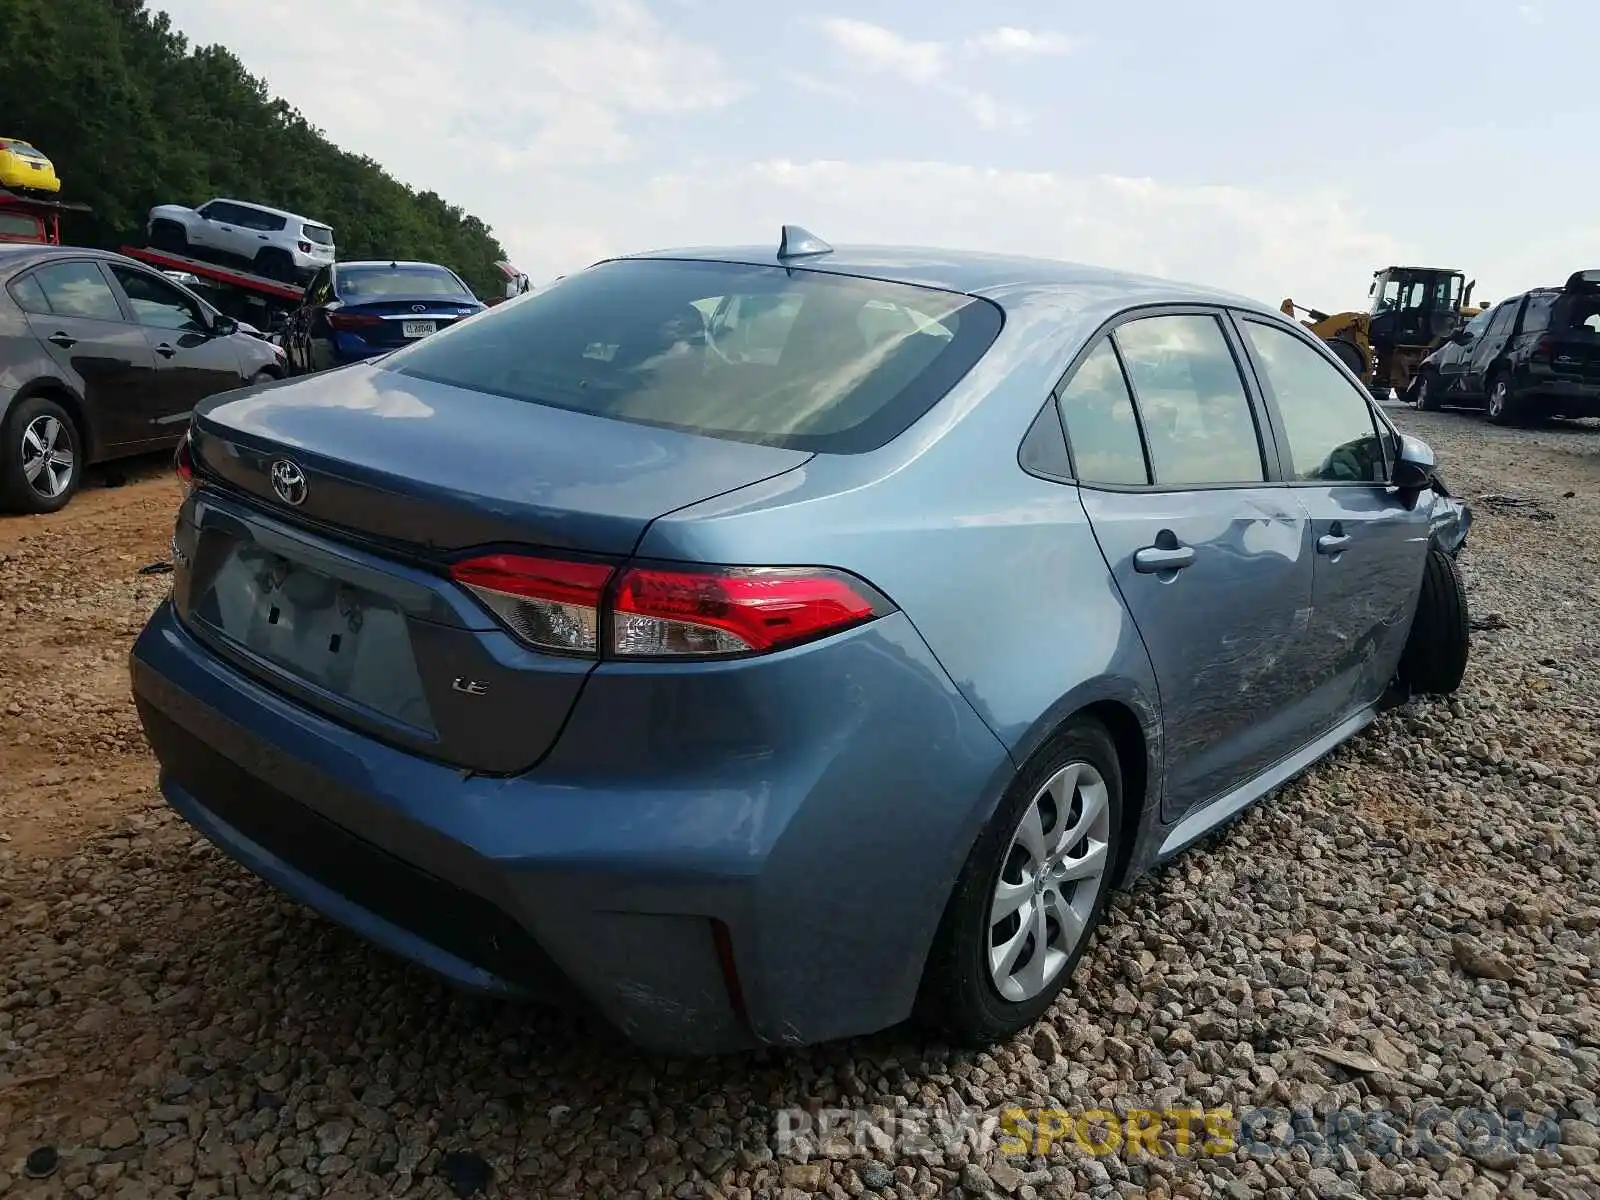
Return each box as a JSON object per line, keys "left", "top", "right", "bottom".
{"left": 917, "top": 718, "right": 1123, "bottom": 1048}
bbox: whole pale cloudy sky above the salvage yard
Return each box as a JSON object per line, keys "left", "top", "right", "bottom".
{"left": 152, "top": 0, "right": 1600, "bottom": 310}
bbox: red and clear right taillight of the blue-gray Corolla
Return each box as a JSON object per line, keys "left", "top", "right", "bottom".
{"left": 450, "top": 554, "right": 893, "bottom": 659}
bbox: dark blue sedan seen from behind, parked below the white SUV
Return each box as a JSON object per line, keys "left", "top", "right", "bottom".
{"left": 283, "top": 261, "right": 486, "bottom": 374}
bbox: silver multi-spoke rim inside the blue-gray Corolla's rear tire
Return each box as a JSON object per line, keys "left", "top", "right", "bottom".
{"left": 989, "top": 762, "right": 1110, "bottom": 1003}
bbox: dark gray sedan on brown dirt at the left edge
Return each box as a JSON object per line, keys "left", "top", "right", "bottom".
{"left": 0, "top": 246, "right": 283, "bottom": 512}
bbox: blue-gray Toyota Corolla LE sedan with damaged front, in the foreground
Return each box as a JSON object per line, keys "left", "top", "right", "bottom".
{"left": 131, "top": 227, "right": 1469, "bottom": 1053}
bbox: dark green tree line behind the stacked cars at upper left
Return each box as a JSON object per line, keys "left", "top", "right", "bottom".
{"left": 0, "top": 0, "right": 506, "bottom": 298}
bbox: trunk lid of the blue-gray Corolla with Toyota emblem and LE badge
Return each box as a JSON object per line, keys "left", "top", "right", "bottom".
{"left": 174, "top": 366, "right": 810, "bottom": 774}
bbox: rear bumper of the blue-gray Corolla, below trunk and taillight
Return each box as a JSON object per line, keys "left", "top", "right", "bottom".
{"left": 131, "top": 605, "right": 1011, "bottom": 1053}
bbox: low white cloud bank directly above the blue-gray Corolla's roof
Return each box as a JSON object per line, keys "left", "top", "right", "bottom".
{"left": 507, "top": 160, "right": 1418, "bottom": 310}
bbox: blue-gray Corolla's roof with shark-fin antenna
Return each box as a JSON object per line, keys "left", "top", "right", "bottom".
{"left": 618, "top": 245, "right": 1275, "bottom": 312}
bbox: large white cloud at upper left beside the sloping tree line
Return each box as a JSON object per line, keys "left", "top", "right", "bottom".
{"left": 158, "top": 0, "right": 739, "bottom": 173}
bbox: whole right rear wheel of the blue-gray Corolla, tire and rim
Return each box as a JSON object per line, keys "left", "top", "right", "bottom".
{"left": 918, "top": 718, "right": 1123, "bottom": 1046}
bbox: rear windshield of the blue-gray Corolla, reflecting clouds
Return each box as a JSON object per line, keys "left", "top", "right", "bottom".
{"left": 386, "top": 259, "right": 1002, "bottom": 453}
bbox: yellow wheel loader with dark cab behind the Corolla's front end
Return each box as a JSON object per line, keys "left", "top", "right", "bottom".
{"left": 1278, "top": 267, "right": 1486, "bottom": 400}
